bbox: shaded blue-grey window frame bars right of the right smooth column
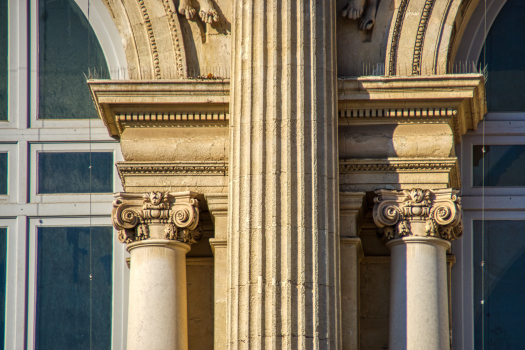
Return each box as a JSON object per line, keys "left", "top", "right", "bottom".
{"left": 451, "top": 112, "right": 525, "bottom": 350}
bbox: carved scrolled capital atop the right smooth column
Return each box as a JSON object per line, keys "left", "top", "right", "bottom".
{"left": 374, "top": 188, "right": 463, "bottom": 241}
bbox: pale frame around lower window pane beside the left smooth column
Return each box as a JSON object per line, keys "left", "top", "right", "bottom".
{"left": 26, "top": 216, "right": 129, "bottom": 349}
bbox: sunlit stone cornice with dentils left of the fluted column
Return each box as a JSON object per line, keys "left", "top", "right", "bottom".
{"left": 88, "top": 79, "right": 230, "bottom": 137}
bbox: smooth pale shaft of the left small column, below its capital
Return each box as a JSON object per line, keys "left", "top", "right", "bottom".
{"left": 128, "top": 239, "right": 190, "bottom": 350}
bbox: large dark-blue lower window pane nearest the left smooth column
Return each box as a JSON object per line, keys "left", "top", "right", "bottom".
{"left": 36, "top": 227, "right": 113, "bottom": 350}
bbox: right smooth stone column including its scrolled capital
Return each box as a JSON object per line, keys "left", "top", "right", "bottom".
{"left": 374, "top": 189, "right": 463, "bottom": 350}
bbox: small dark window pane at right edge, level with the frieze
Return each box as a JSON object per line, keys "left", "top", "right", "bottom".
{"left": 472, "top": 145, "right": 525, "bottom": 187}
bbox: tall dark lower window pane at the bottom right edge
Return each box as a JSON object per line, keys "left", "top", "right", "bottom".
{"left": 474, "top": 220, "right": 525, "bottom": 350}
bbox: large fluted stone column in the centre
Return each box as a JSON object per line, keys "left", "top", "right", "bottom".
{"left": 227, "top": 0, "right": 341, "bottom": 349}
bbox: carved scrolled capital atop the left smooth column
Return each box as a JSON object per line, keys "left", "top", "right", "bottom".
{"left": 111, "top": 192, "right": 202, "bottom": 244}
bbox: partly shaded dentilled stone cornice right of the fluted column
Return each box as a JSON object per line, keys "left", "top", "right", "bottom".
{"left": 338, "top": 74, "right": 487, "bottom": 143}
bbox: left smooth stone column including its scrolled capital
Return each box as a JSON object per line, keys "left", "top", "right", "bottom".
{"left": 112, "top": 192, "right": 202, "bottom": 350}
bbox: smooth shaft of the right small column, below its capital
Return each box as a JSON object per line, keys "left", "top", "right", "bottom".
{"left": 387, "top": 237, "right": 450, "bottom": 350}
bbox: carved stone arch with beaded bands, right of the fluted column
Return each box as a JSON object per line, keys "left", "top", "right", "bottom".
{"left": 385, "top": 0, "right": 494, "bottom": 75}
